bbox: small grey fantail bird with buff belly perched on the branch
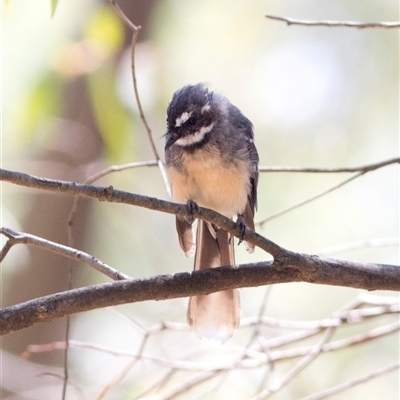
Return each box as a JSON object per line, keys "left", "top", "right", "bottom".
{"left": 165, "top": 83, "right": 258, "bottom": 342}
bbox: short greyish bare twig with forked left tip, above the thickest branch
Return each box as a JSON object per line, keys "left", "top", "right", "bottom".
{"left": 0, "top": 228, "right": 129, "bottom": 280}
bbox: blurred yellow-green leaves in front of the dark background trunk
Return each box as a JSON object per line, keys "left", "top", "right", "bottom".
{"left": 5, "top": 2, "right": 133, "bottom": 162}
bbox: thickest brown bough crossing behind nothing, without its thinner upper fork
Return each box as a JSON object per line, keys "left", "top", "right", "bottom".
{"left": 0, "top": 255, "right": 400, "bottom": 335}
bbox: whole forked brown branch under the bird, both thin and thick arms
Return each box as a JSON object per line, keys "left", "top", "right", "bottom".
{"left": 0, "top": 170, "right": 400, "bottom": 334}
